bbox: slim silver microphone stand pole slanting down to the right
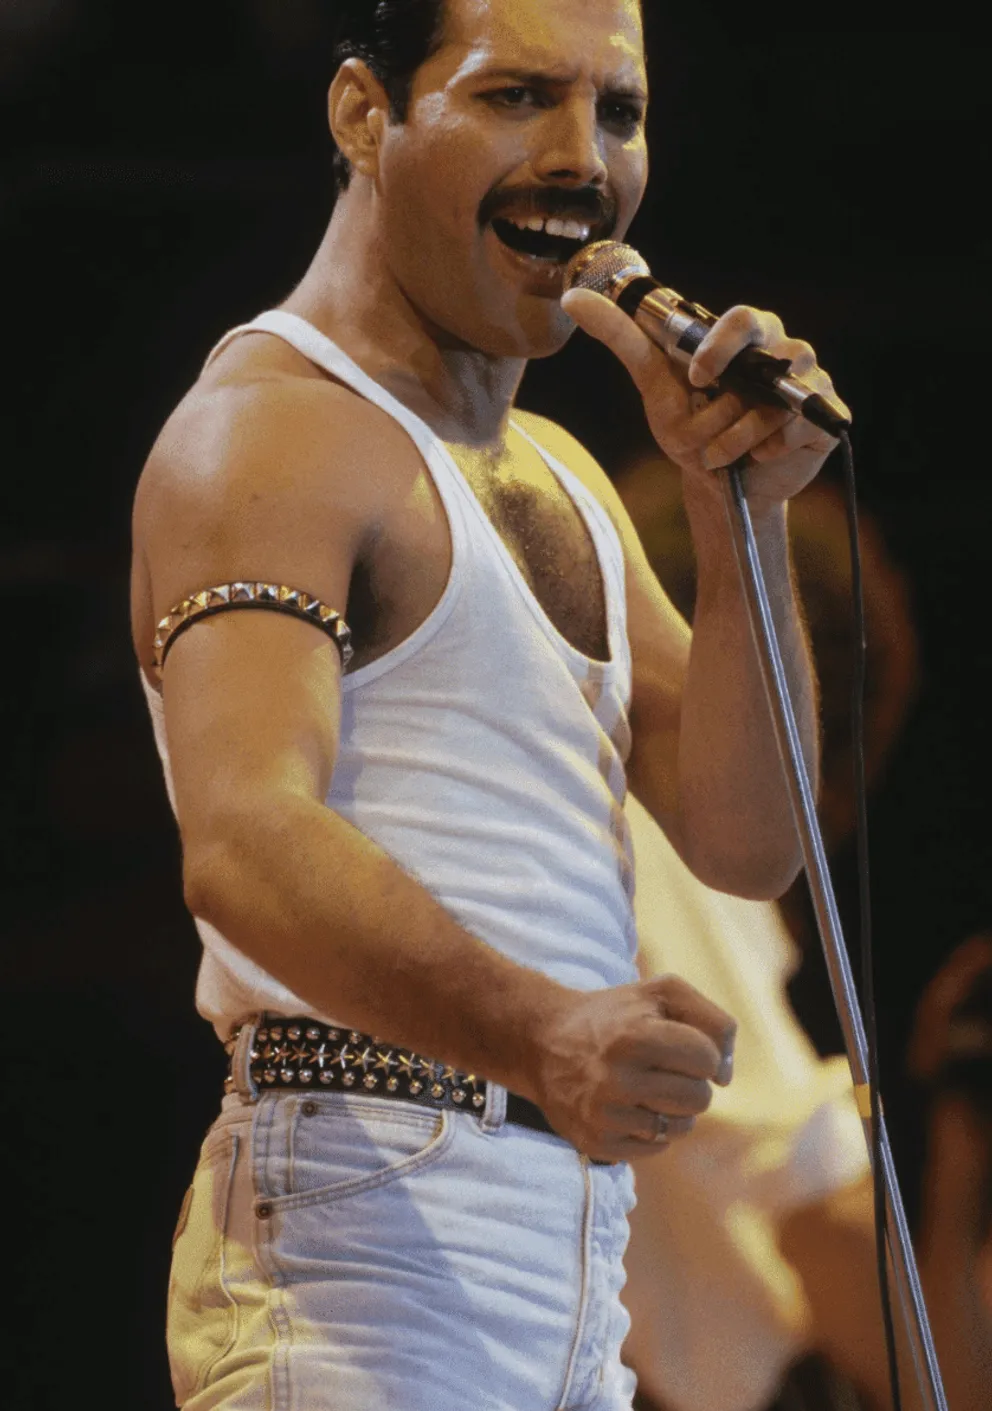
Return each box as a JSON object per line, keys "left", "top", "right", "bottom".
{"left": 720, "top": 464, "right": 947, "bottom": 1411}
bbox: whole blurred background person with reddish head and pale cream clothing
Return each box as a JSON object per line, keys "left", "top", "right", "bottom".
{"left": 617, "top": 454, "right": 925, "bottom": 1411}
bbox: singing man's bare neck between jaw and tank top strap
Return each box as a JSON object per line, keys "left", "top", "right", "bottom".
{"left": 282, "top": 196, "right": 526, "bottom": 449}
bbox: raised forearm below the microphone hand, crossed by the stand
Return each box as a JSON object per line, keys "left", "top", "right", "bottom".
{"left": 679, "top": 479, "right": 818, "bottom": 896}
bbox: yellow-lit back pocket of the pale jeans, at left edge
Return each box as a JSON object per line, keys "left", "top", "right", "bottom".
{"left": 167, "top": 1127, "right": 240, "bottom": 1405}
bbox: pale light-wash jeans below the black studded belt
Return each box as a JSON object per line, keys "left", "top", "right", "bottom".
{"left": 168, "top": 1027, "right": 634, "bottom": 1411}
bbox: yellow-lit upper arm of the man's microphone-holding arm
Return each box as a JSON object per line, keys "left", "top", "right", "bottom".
{"left": 516, "top": 416, "right": 690, "bottom": 848}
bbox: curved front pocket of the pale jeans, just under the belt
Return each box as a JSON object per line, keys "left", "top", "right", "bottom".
{"left": 260, "top": 1094, "right": 454, "bottom": 1209}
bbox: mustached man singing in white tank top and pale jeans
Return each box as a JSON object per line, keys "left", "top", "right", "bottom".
{"left": 133, "top": 0, "right": 833, "bottom": 1411}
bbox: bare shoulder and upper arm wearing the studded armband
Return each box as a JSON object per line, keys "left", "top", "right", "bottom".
{"left": 134, "top": 382, "right": 374, "bottom": 855}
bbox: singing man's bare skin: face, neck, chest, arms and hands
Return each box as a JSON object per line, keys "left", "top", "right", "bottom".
{"left": 133, "top": 0, "right": 846, "bottom": 1160}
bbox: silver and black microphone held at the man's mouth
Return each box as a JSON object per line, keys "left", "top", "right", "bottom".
{"left": 564, "top": 240, "right": 851, "bottom": 436}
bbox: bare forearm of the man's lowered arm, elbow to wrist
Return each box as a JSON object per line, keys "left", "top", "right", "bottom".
{"left": 186, "top": 793, "right": 567, "bottom": 1096}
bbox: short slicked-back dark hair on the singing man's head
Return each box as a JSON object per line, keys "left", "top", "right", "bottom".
{"left": 333, "top": 0, "right": 446, "bottom": 195}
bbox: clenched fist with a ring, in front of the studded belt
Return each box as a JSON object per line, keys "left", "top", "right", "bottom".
{"left": 532, "top": 975, "right": 737, "bottom": 1161}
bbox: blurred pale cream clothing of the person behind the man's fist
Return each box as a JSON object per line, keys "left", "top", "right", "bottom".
{"left": 625, "top": 800, "right": 872, "bottom": 1411}
